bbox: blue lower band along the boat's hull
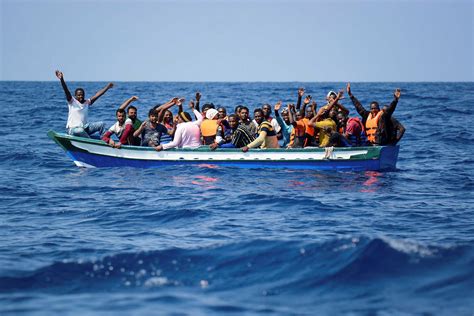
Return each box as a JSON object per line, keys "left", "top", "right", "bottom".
{"left": 67, "top": 147, "right": 398, "bottom": 171}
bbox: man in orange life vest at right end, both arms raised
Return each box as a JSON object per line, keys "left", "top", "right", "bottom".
{"left": 346, "top": 83, "right": 401, "bottom": 146}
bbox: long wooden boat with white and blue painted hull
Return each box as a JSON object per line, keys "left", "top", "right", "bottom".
{"left": 48, "top": 131, "right": 399, "bottom": 171}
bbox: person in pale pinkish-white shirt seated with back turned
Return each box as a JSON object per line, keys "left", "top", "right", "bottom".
{"left": 155, "top": 101, "right": 202, "bottom": 151}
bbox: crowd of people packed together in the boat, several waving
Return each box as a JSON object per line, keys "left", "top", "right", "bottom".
{"left": 56, "top": 70, "right": 405, "bottom": 152}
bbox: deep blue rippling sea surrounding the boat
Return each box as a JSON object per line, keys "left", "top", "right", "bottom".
{"left": 0, "top": 82, "right": 474, "bottom": 315}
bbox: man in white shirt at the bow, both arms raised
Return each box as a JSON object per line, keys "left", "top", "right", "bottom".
{"left": 56, "top": 70, "right": 114, "bottom": 138}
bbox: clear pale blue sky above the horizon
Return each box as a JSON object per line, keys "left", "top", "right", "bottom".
{"left": 0, "top": 0, "right": 474, "bottom": 82}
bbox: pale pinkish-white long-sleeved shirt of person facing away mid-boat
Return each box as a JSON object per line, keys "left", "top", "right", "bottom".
{"left": 163, "top": 110, "right": 202, "bottom": 149}
